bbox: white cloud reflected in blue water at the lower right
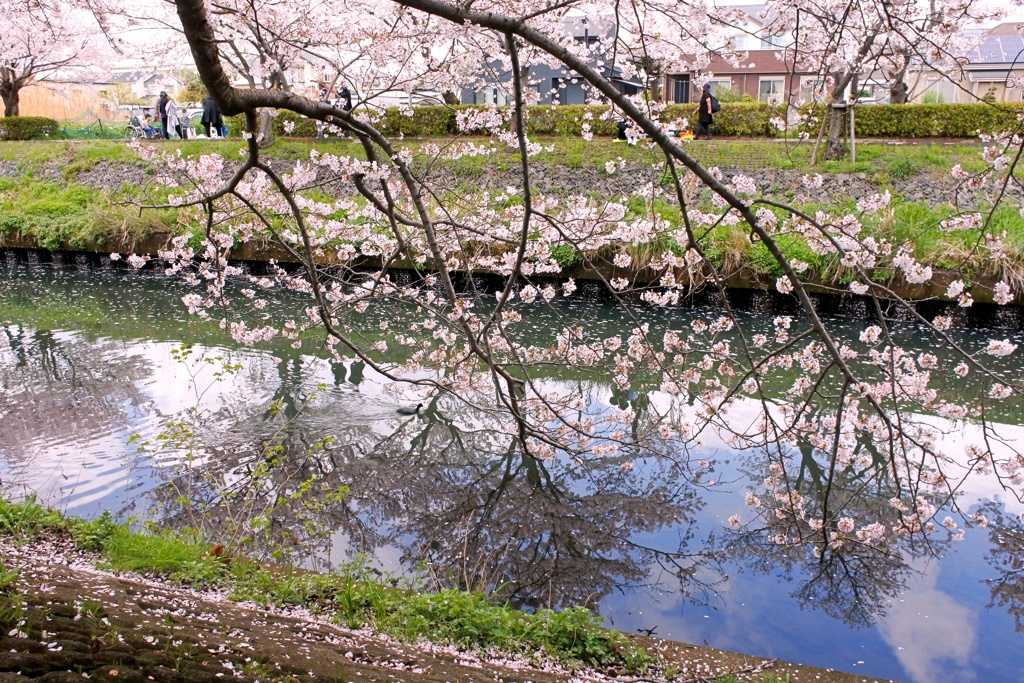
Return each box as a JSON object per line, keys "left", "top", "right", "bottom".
{"left": 879, "top": 562, "right": 977, "bottom": 683}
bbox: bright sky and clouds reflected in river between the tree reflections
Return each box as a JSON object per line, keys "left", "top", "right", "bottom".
{"left": 0, "top": 264, "right": 1024, "bottom": 683}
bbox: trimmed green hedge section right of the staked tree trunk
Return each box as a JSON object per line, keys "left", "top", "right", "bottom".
{"left": 802, "top": 103, "right": 1024, "bottom": 137}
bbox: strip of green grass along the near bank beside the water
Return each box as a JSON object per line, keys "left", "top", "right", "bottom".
{"left": 0, "top": 498, "right": 781, "bottom": 683}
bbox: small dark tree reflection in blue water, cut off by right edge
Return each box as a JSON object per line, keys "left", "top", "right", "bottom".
{"left": 975, "top": 503, "right": 1024, "bottom": 631}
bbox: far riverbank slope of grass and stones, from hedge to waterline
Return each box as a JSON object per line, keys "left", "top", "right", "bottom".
{"left": 0, "top": 138, "right": 1024, "bottom": 302}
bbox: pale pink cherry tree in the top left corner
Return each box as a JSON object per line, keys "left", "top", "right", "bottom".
{"left": 0, "top": 0, "right": 105, "bottom": 116}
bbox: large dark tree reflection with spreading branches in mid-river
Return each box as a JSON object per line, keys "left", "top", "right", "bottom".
{"left": 360, "top": 401, "right": 709, "bottom": 606}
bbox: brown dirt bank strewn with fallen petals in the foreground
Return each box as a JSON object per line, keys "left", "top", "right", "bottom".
{"left": 0, "top": 538, "right": 897, "bottom": 683}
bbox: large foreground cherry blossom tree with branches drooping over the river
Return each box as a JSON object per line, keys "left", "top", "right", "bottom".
{"left": 103, "top": 0, "right": 1024, "bottom": 600}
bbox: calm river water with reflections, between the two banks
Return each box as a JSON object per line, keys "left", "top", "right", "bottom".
{"left": 0, "top": 262, "right": 1024, "bottom": 683}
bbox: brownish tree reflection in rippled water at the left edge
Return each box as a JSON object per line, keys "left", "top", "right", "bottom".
{"left": 0, "top": 325, "right": 150, "bottom": 463}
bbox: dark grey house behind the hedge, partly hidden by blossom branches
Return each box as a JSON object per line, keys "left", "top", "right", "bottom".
{"left": 460, "top": 15, "right": 643, "bottom": 104}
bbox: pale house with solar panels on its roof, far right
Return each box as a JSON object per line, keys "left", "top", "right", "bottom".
{"left": 907, "top": 23, "right": 1024, "bottom": 103}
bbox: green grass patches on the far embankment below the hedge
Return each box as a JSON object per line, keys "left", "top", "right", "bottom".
{"left": 0, "top": 138, "right": 1024, "bottom": 296}
